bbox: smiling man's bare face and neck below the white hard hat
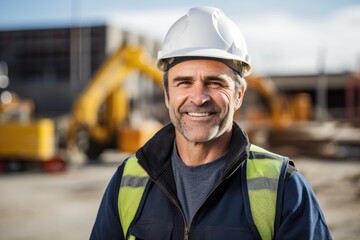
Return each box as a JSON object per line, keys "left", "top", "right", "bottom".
{"left": 165, "top": 59, "right": 244, "bottom": 166}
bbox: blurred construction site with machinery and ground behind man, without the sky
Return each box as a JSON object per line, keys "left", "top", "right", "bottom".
{"left": 0, "top": 16, "right": 360, "bottom": 240}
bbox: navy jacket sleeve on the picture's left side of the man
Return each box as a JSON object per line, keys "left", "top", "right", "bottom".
{"left": 90, "top": 165, "right": 124, "bottom": 240}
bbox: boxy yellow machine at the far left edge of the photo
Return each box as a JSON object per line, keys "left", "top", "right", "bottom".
{"left": 0, "top": 92, "right": 66, "bottom": 172}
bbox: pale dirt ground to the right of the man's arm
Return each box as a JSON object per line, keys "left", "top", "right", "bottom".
{"left": 295, "top": 159, "right": 360, "bottom": 240}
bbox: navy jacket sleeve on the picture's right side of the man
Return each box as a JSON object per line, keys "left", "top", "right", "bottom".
{"left": 275, "top": 171, "right": 332, "bottom": 240}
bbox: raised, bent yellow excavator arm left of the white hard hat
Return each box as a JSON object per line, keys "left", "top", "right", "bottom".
{"left": 68, "top": 46, "right": 162, "bottom": 157}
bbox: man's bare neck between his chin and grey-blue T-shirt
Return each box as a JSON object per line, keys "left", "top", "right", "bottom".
{"left": 176, "top": 131, "right": 232, "bottom": 166}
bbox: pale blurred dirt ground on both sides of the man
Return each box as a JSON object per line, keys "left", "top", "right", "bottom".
{"left": 0, "top": 155, "right": 360, "bottom": 240}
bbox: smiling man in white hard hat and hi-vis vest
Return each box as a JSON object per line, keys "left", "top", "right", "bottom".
{"left": 91, "top": 7, "right": 331, "bottom": 240}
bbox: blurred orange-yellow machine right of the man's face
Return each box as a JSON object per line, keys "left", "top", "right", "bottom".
{"left": 237, "top": 74, "right": 312, "bottom": 154}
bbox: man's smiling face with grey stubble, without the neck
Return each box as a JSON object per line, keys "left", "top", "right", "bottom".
{"left": 165, "top": 59, "right": 243, "bottom": 143}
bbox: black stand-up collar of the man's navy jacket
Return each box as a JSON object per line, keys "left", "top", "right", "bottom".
{"left": 136, "top": 122, "right": 250, "bottom": 179}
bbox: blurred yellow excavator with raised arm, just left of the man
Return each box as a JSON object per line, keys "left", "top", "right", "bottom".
{"left": 68, "top": 46, "right": 162, "bottom": 159}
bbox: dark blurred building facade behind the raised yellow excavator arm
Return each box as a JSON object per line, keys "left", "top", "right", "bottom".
{"left": 0, "top": 25, "right": 159, "bottom": 116}
